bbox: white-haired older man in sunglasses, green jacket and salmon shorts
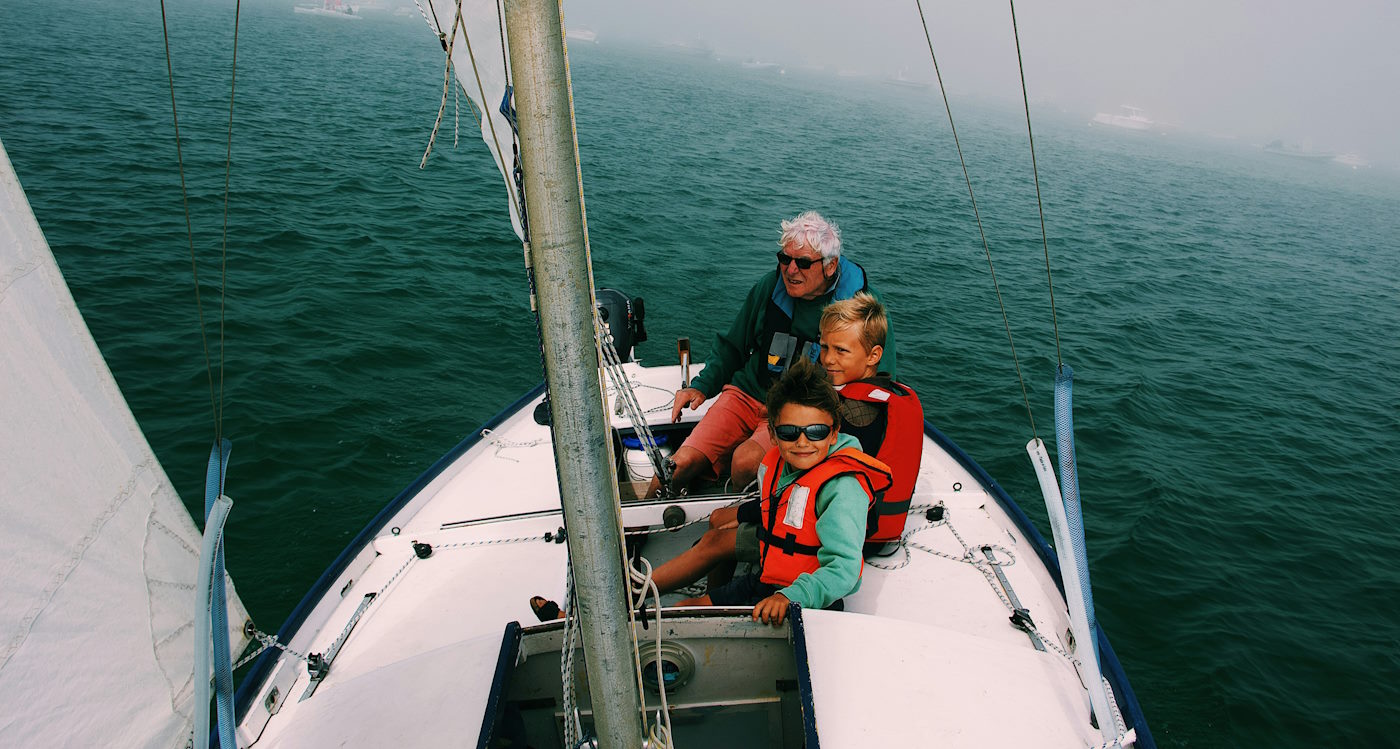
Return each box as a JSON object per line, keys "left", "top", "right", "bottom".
{"left": 652, "top": 211, "right": 896, "bottom": 490}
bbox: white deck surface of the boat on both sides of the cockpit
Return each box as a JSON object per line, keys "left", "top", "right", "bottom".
{"left": 239, "top": 364, "right": 1105, "bottom": 748}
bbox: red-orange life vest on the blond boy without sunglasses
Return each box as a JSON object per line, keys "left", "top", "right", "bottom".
{"left": 840, "top": 381, "right": 924, "bottom": 543}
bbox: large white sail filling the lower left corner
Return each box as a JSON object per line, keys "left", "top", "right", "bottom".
{"left": 0, "top": 144, "right": 248, "bottom": 748}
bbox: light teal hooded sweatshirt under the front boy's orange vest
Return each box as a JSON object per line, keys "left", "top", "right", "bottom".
{"left": 777, "top": 434, "right": 871, "bottom": 609}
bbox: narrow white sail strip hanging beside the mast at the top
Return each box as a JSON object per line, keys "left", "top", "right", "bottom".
{"left": 419, "top": 0, "right": 525, "bottom": 241}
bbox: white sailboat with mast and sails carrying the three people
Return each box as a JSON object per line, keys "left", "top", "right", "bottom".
{"left": 0, "top": 1, "right": 1152, "bottom": 748}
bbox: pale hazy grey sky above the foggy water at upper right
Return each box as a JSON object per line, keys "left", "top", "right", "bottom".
{"left": 564, "top": 0, "right": 1400, "bottom": 164}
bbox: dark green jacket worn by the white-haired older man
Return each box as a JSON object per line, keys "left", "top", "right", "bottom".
{"left": 690, "top": 260, "right": 899, "bottom": 402}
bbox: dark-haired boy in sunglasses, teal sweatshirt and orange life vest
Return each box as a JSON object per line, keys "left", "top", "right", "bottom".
{"left": 672, "top": 361, "right": 892, "bottom": 626}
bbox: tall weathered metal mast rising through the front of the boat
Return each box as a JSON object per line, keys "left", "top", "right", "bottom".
{"left": 505, "top": 0, "right": 643, "bottom": 749}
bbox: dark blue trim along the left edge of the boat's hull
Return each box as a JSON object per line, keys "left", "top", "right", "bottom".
{"left": 234, "top": 382, "right": 545, "bottom": 722}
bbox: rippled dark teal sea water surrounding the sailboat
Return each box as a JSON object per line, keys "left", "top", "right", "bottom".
{"left": 0, "top": 0, "right": 1400, "bottom": 748}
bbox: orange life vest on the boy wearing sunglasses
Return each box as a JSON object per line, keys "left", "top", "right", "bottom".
{"left": 759, "top": 448, "right": 892, "bottom": 585}
